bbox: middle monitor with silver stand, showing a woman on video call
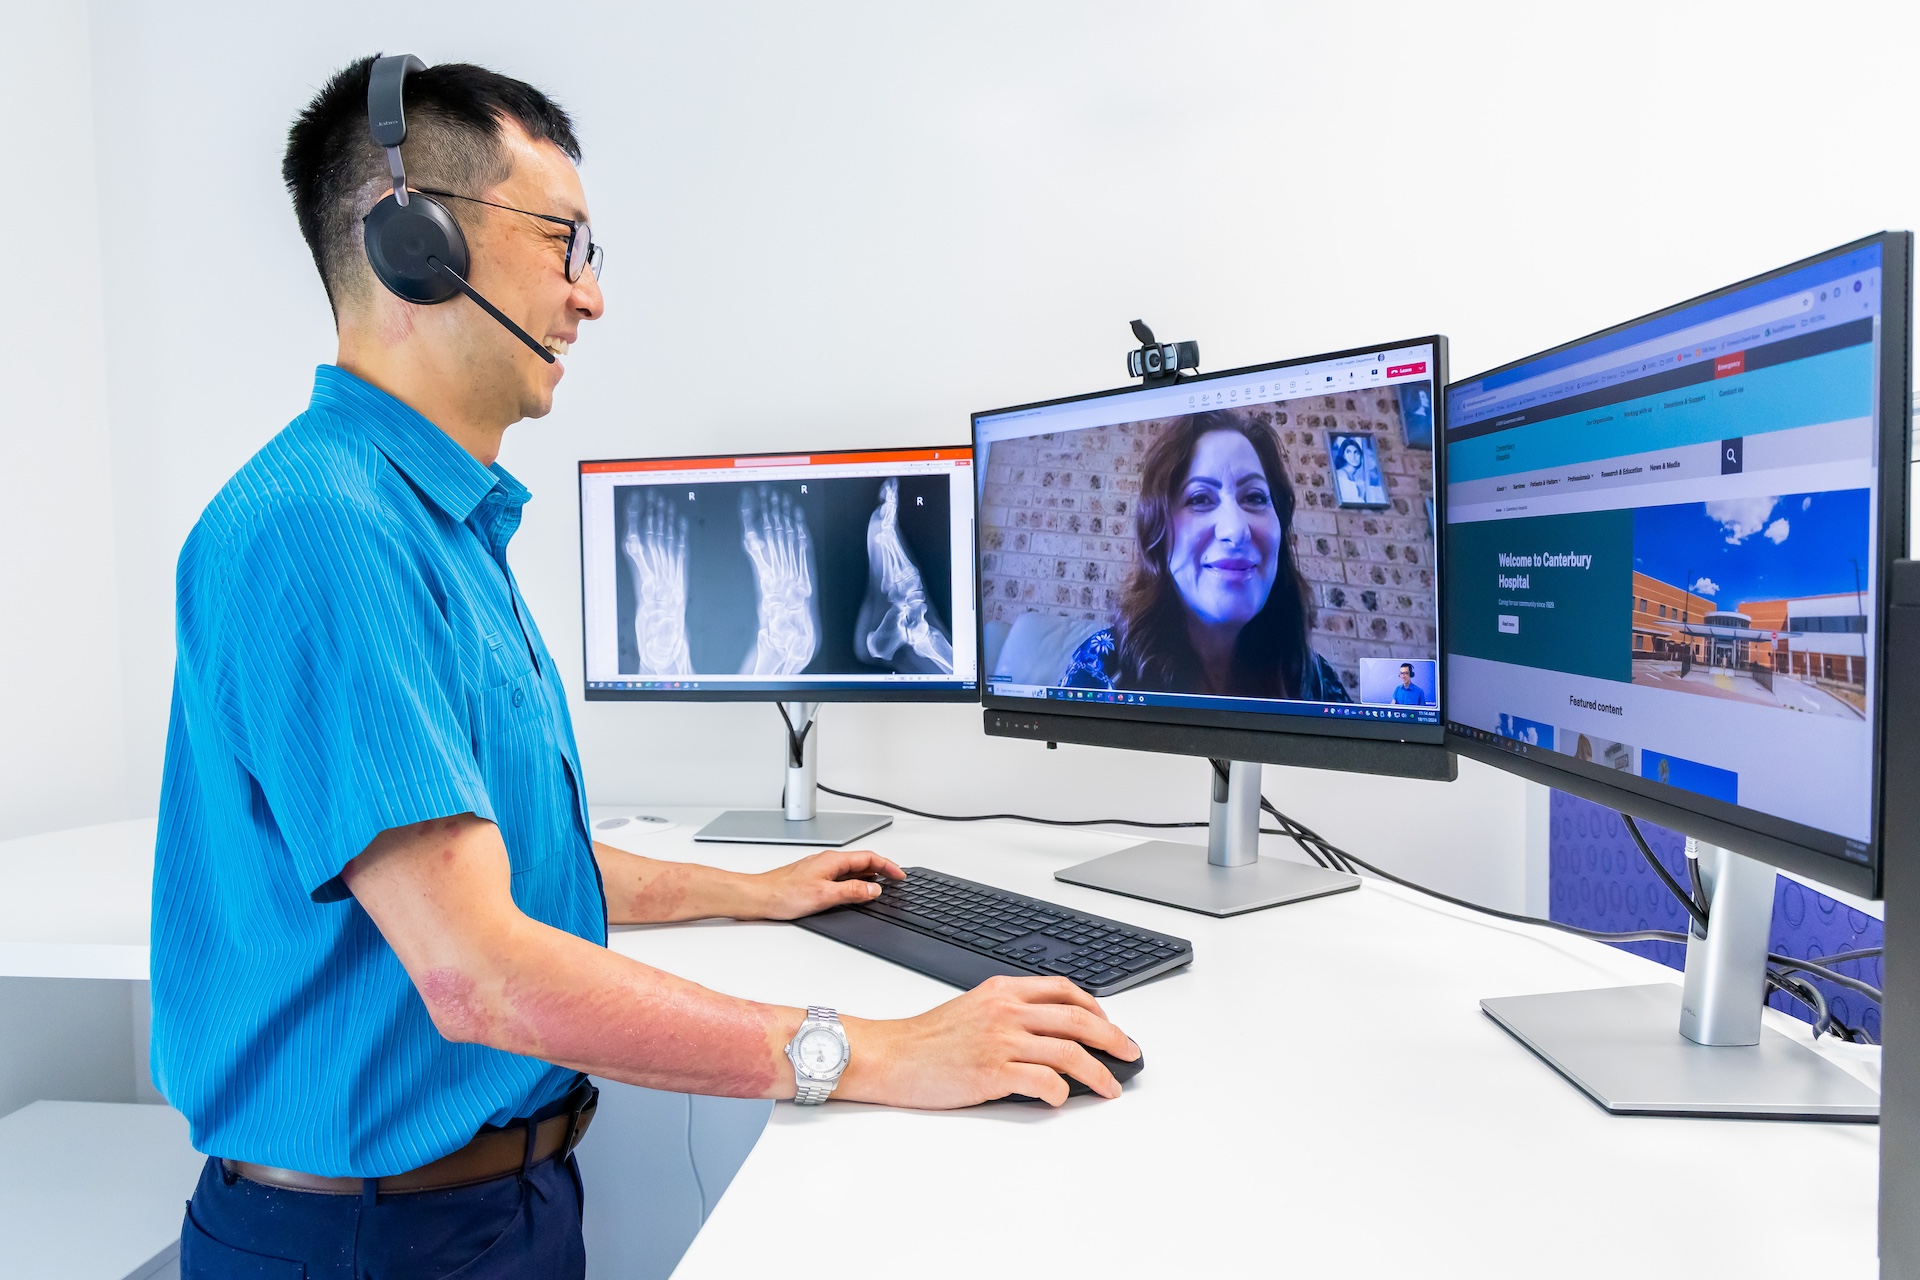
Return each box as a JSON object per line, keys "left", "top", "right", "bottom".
{"left": 973, "top": 336, "right": 1453, "bottom": 915}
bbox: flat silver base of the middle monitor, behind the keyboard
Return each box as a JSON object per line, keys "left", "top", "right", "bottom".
{"left": 1054, "top": 841, "right": 1359, "bottom": 915}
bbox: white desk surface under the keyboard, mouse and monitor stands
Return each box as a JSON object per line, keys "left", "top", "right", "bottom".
{"left": 599, "top": 808, "right": 1878, "bottom": 1280}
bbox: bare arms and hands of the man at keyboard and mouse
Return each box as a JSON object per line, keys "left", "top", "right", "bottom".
{"left": 344, "top": 814, "right": 1139, "bottom": 1107}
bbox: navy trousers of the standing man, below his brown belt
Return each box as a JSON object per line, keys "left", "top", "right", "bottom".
{"left": 180, "top": 1155, "right": 588, "bottom": 1280}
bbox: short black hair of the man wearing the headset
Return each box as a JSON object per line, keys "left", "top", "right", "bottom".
{"left": 280, "top": 54, "right": 580, "bottom": 317}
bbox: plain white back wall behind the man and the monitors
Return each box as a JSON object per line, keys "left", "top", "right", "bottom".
{"left": 18, "top": 0, "right": 1916, "bottom": 906}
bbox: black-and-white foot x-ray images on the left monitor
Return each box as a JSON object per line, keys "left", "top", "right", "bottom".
{"left": 614, "top": 476, "right": 954, "bottom": 679}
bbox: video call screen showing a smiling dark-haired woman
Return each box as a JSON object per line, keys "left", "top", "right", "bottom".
{"left": 973, "top": 345, "right": 1440, "bottom": 725}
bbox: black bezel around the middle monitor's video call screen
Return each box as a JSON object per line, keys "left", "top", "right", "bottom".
{"left": 972, "top": 334, "right": 1453, "bottom": 779}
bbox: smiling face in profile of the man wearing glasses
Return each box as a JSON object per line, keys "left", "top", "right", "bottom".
{"left": 443, "top": 123, "right": 607, "bottom": 422}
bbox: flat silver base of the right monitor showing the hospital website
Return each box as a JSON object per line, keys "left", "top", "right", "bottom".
{"left": 1480, "top": 983, "right": 1880, "bottom": 1125}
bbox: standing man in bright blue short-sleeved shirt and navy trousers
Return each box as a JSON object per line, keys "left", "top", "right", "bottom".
{"left": 154, "top": 59, "right": 1137, "bottom": 1280}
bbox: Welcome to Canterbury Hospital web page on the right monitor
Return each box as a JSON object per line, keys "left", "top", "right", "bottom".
{"left": 1446, "top": 248, "right": 1880, "bottom": 856}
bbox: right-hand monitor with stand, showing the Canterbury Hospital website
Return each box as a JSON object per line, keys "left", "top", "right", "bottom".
{"left": 1444, "top": 232, "right": 1912, "bottom": 1119}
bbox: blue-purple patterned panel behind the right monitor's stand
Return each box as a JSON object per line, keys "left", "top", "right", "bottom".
{"left": 1548, "top": 791, "right": 1884, "bottom": 1040}
